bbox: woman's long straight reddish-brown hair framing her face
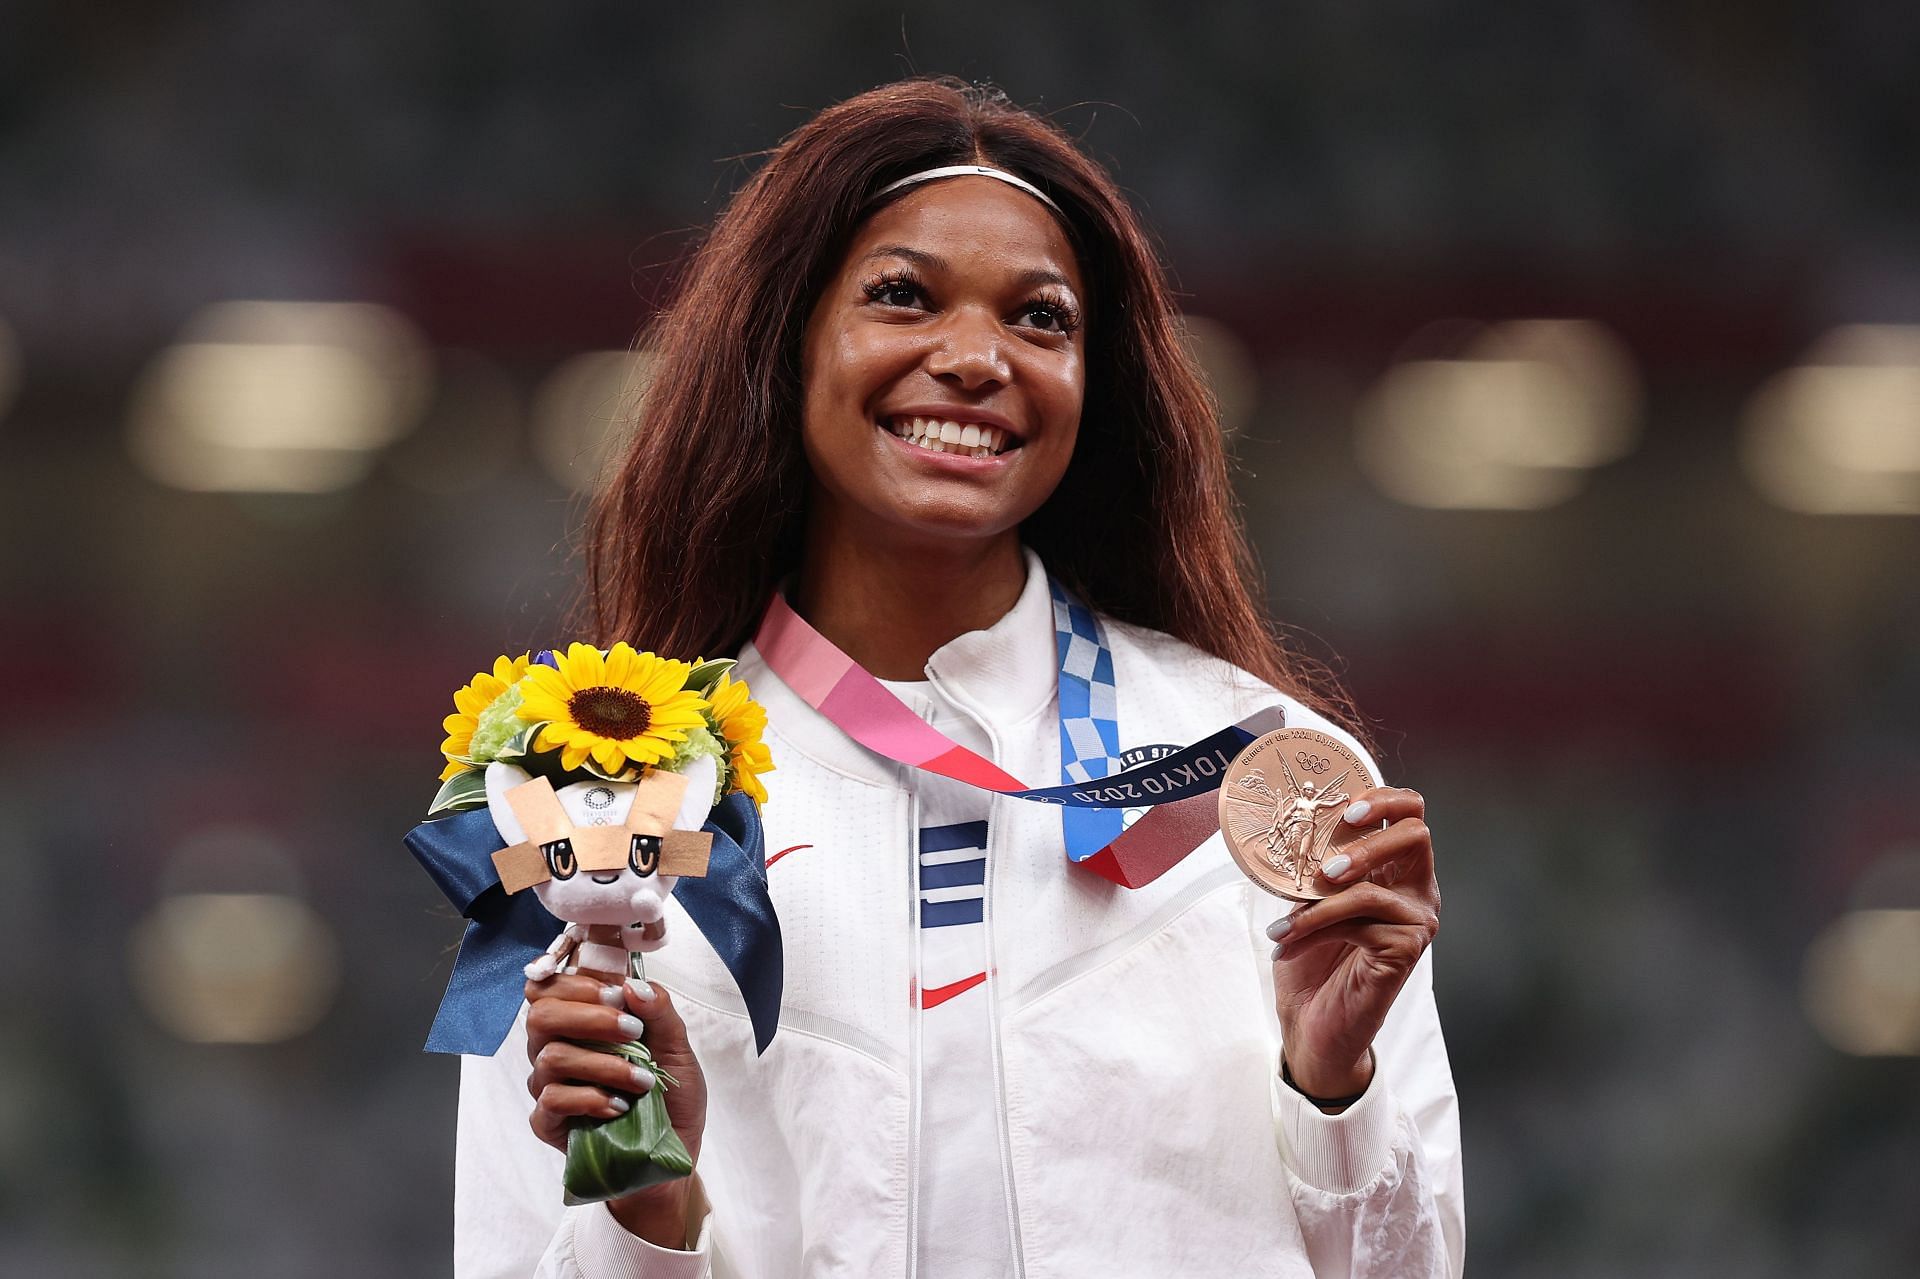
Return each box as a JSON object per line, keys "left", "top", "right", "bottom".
{"left": 584, "top": 79, "right": 1352, "bottom": 722}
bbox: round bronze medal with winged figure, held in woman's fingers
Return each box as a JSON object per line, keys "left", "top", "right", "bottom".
{"left": 1219, "top": 728, "right": 1379, "bottom": 901}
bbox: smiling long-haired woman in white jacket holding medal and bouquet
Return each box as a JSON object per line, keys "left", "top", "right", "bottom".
{"left": 457, "top": 81, "right": 1461, "bottom": 1275}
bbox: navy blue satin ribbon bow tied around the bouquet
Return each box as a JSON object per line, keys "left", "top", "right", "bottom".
{"left": 407, "top": 791, "right": 785, "bottom": 1056}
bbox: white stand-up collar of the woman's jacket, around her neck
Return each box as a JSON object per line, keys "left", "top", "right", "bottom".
{"left": 739, "top": 549, "right": 1060, "bottom": 785}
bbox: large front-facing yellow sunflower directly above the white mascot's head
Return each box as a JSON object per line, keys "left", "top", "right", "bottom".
{"left": 518, "top": 641, "right": 707, "bottom": 776}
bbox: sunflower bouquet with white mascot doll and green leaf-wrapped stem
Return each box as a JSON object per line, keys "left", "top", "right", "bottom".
{"left": 420, "top": 643, "right": 778, "bottom": 1204}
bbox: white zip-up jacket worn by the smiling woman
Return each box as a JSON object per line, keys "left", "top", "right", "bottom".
{"left": 455, "top": 555, "right": 1465, "bottom": 1279}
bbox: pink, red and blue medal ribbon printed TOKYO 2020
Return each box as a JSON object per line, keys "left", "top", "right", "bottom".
{"left": 753, "top": 582, "right": 1286, "bottom": 887}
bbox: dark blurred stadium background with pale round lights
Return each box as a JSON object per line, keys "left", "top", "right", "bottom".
{"left": 0, "top": 0, "right": 1920, "bottom": 1277}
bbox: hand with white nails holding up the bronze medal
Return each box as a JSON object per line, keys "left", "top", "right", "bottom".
{"left": 1267, "top": 785, "right": 1440, "bottom": 1097}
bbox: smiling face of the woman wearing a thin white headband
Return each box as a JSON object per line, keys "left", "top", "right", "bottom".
{"left": 803, "top": 177, "right": 1087, "bottom": 545}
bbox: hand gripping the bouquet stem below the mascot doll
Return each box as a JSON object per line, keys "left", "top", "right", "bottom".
{"left": 526, "top": 974, "right": 707, "bottom": 1248}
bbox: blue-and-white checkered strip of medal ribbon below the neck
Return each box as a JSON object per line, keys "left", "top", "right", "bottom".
{"left": 1046, "top": 578, "right": 1123, "bottom": 862}
